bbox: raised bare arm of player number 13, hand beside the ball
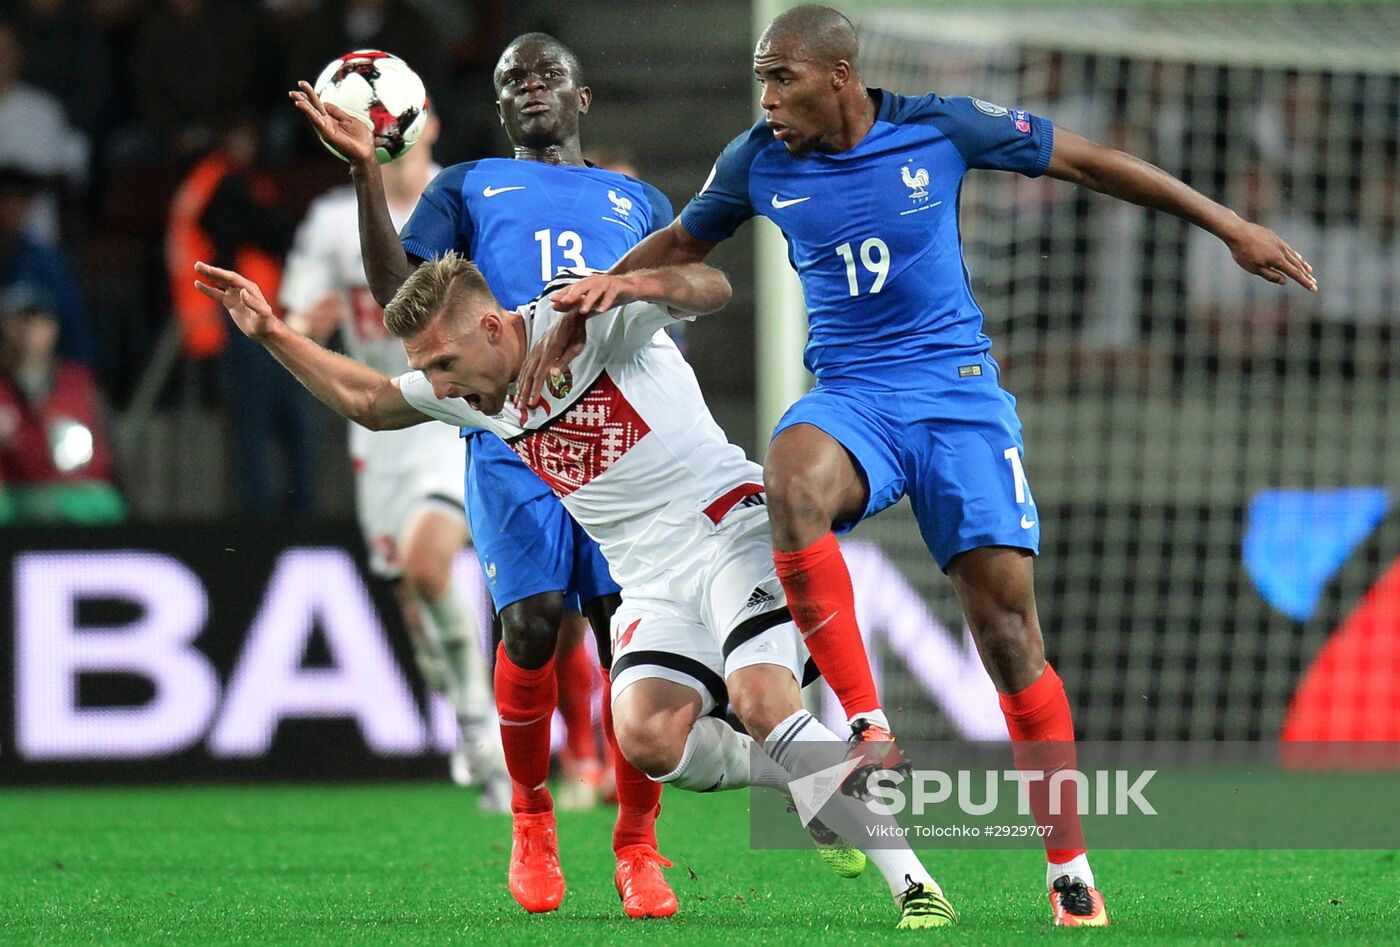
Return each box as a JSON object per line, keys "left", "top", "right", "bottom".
{"left": 287, "top": 81, "right": 413, "bottom": 305}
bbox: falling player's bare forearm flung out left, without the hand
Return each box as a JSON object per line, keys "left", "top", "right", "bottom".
{"left": 258, "top": 324, "right": 428, "bottom": 430}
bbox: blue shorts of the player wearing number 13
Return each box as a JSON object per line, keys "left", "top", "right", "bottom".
{"left": 463, "top": 431, "right": 622, "bottom": 612}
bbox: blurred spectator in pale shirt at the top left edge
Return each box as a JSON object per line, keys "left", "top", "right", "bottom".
{"left": 0, "top": 21, "right": 88, "bottom": 244}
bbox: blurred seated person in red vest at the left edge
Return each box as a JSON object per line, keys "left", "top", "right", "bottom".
{"left": 0, "top": 284, "right": 126, "bottom": 523}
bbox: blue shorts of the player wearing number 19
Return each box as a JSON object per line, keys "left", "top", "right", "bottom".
{"left": 778, "top": 354, "right": 1040, "bottom": 570}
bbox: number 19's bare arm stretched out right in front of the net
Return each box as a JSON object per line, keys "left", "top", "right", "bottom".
{"left": 1047, "top": 127, "right": 1317, "bottom": 293}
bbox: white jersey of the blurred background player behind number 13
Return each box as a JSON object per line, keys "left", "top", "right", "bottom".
{"left": 279, "top": 165, "right": 465, "bottom": 476}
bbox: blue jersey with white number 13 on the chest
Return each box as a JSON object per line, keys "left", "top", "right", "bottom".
{"left": 400, "top": 158, "right": 672, "bottom": 308}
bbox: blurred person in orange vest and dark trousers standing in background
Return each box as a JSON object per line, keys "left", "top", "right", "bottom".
{"left": 165, "top": 115, "right": 315, "bottom": 517}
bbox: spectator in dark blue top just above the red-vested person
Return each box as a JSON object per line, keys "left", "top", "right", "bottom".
{"left": 0, "top": 165, "right": 95, "bottom": 367}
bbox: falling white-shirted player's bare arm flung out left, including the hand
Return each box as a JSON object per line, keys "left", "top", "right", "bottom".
{"left": 195, "top": 263, "right": 428, "bottom": 430}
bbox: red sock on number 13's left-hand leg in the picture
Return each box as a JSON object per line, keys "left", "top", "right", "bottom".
{"left": 496, "top": 644, "right": 559, "bottom": 813}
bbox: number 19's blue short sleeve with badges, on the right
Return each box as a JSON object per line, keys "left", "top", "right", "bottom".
{"left": 911, "top": 95, "right": 1054, "bottom": 178}
